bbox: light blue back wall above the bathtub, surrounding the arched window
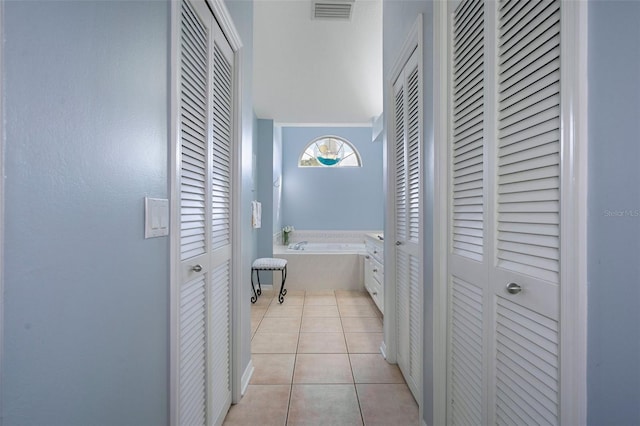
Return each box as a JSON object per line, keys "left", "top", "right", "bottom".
{"left": 282, "top": 127, "right": 384, "bottom": 230}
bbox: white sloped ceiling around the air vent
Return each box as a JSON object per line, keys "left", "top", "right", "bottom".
{"left": 253, "top": 0, "right": 382, "bottom": 124}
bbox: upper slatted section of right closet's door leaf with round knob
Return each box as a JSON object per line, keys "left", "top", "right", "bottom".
{"left": 497, "top": 1, "right": 560, "bottom": 282}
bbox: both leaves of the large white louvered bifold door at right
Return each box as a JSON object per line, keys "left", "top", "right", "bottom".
{"left": 449, "top": 0, "right": 561, "bottom": 425}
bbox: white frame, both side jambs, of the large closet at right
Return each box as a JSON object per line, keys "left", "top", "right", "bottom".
{"left": 432, "top": 0, "right": 588, "bottom": 424}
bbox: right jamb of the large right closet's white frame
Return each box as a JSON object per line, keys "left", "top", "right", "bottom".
{"left": 560, "top": 1, "right": 589, "bottom": 424}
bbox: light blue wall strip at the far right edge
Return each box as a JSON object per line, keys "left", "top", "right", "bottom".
{"left": 587, "top": 1, "right": 640, "bottom": 425}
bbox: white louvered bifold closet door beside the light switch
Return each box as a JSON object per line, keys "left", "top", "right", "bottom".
{"left": 177, "top": 0, "right": 232, "bottom": 426}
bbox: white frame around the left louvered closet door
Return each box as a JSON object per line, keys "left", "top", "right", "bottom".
{"left": 169, "top": 0, "right": 242, "bottom": 426}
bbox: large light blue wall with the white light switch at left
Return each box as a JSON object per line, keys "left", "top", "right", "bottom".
{"left": 2, "top": 1, "right": 169, "bottom": 426}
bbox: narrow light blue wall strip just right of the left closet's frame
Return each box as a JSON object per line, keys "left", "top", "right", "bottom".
{"left": 225, "top": 0, "right": 258, "bottom": 388}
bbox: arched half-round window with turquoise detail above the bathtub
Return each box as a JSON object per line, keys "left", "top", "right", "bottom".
{"left": 298, "top": 136, "right": 362, "bottom": 167}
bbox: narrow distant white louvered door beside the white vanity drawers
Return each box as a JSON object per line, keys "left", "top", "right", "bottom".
{"left": 394, "top": 47, "right": 422, "bottom": 401}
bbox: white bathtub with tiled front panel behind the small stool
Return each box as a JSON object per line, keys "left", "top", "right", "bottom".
{"left": 273, "top": 243, "right": 365, "bottom": 292}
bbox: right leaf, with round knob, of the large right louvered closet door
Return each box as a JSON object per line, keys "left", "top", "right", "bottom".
{"left": 490, "top": 0, "right": 560, "bottom": 424}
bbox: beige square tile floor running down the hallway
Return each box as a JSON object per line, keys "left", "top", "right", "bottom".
{"left": 224, "top": 290, "right": 419, "bottom": 426}
